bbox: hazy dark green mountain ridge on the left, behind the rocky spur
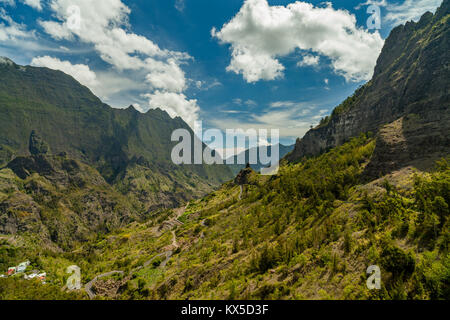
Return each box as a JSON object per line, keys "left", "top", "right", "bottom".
{"left": 0, "top": 58, "right": 232, "bottom": 211}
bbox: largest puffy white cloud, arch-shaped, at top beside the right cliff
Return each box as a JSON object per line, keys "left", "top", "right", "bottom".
{"left": 211, "top": 0, "right": 384, "bottom": 82}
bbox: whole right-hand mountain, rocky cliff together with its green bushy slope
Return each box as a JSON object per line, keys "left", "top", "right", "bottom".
{"left": 47, "top": 1, "right": 450, "bottom": 300}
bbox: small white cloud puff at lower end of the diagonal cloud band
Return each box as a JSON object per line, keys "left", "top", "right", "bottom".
{"left": 144, "top": 91, "right": 200, "bottom": 127}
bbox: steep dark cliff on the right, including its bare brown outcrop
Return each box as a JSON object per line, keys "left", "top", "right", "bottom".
{"left": 286, "top": 0, "right": 450, "bottom": 178}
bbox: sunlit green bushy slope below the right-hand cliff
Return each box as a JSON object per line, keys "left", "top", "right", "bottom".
{"left": 2, "top": 136, "right": 450, "bottom": 299}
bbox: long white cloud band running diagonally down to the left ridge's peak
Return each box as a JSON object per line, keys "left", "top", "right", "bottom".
{"left": 39, "top": 0, "right": 199, "bottom": 127}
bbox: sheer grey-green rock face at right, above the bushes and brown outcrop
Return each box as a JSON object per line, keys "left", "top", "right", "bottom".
{"left": 287, "top": 0, "right": 450, "bottom": 171}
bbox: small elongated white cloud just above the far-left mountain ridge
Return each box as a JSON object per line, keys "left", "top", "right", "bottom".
{"left": 31, "top": 56, "right": 98, "bottom": 88}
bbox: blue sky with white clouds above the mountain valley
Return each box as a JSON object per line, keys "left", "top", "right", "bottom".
{"left": 0, "top": 0, "right": 441, "bottom": 148}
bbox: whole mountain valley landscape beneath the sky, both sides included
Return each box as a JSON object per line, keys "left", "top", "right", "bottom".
{"left": 0, "top": 0, "right": 450, "bottom": 300}
